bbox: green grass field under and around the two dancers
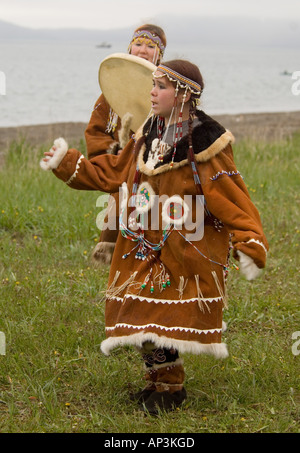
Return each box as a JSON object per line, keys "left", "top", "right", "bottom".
{"left": 0, "top": 135, "right": 300, "bottom": 433}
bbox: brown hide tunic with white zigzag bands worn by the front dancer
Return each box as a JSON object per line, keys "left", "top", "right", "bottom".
{"left": 55, "top": 112, "right": 268, "bottom": 357}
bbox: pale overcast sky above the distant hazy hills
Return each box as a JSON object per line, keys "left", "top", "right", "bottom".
{"left": 0, "top": 0, "right": 300, "bottom": 32}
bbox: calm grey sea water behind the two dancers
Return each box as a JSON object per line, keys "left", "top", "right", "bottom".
{"left": 0, "top": 40, "right": 300, "bottom": 127}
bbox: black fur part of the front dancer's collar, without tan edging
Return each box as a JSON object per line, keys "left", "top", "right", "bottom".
{"left": 143, "top": 110, "right": 226, "bottom": 168}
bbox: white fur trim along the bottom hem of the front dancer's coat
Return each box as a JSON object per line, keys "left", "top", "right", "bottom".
{"left": 101, "top": 332, "right": 229, "bottom": 359}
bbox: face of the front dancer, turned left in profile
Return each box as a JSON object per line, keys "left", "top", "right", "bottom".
{"left": 150, "top": 71, "right": 175, "bottom": 121}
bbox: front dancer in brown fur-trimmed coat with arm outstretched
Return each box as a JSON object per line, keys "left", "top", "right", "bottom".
{"left": 42, "top": 60, "right": 268, "bottom": 414}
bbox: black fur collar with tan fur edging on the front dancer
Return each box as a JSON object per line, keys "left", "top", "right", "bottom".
{"left": 138, "top": 111, "right": 234, "bottom": 176}
